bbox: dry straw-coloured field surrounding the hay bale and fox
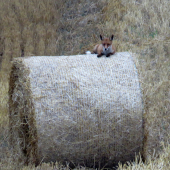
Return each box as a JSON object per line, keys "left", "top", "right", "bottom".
{"left": 0, "top": 0, "right": 170, "bottom": 170}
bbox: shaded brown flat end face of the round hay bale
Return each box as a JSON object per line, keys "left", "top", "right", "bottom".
{"left": 9, "top": 59, "right": 39, "bottom": 165}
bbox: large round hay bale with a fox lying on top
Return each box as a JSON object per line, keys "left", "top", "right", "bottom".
{"left": 9, "top": 52, "right": 143, "bottom": 167}
